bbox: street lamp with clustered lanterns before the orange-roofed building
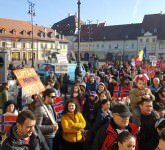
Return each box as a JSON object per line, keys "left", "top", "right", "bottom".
{"left": 28, "top": 1, "right": 35, "bottom": 68}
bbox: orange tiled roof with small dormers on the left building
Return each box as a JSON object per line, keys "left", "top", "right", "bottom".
{"left": 0, "top": 18, "right": 66, "bottom": 42}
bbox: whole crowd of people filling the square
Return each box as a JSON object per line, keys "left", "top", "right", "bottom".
{"left": 0, "top": 60, "right": 165, "bottom": 150}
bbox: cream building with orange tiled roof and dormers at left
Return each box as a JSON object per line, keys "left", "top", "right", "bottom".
{"left": 0, "top": 18, "right": 68, "bottom": 61}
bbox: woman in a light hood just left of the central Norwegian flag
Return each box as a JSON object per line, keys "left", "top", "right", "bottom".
{"left": 97, "top": 82, "right": 112, "bottom": 100}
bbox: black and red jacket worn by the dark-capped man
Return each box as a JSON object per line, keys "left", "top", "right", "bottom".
{"left": 92, "top": 119, "right": 139, "bottom": 150}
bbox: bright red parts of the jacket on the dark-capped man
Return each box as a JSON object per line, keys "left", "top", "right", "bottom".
{"left": 101, "top": 123, "right": 139, "bottom": 150}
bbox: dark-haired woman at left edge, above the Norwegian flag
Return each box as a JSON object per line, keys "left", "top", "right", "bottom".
{"left": 3, "top": 100, "right": 18, "bottom": 116}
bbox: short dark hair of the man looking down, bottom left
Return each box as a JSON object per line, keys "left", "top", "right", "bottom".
{"left": 16, "top": 110, "right": 36, "bottom": 125}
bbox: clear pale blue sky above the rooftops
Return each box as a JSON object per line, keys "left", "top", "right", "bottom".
{"left": 0, "top": 0, "right": 165, "bottom": 27}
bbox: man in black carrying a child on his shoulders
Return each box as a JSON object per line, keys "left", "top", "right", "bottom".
{"left": 132, "top": 98, "right": 159, "bottom": 150}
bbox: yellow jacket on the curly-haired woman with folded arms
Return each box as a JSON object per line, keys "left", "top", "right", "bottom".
{"left": 61, "top": 112, "right": 86, "bottom": 142}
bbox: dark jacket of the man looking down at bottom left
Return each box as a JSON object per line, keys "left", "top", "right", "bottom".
{"left": 1, "top": 124, "right": 49, "bottom": 150}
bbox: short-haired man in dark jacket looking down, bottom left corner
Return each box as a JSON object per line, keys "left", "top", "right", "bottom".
{"left": 1, "top": 110, "right": 49, "bottom": 150}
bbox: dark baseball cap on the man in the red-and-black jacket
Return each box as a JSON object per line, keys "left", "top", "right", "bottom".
{"left": 112, "top": 103, "right": 132, "bottom": 117}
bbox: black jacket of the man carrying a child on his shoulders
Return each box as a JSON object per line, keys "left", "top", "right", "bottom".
{"left": 132, "top": 107, "right": 159, "bottom": 150}
